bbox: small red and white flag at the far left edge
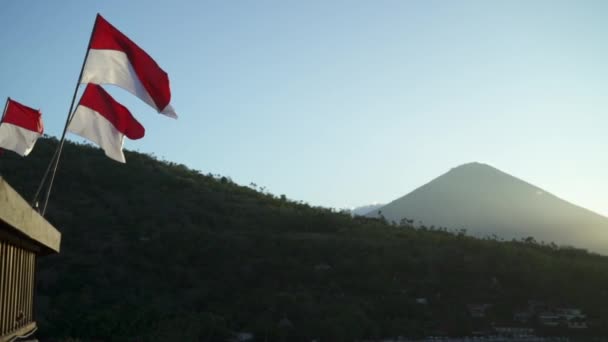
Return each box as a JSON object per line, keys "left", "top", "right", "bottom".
{"left": 0, "top": 98, "right": 44, "bottom": 157}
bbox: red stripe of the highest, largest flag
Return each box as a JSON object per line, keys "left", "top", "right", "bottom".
{"left": 91, "top": 14, "right": 171, "bottom": 112}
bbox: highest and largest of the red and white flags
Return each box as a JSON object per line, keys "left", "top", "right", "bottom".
{"left": 80, "top": 14, "right": 177, "bottom": 118}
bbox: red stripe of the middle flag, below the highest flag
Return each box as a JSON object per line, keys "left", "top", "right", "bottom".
{"left": 80, "top": 83, "right": 146, "bottom": 140}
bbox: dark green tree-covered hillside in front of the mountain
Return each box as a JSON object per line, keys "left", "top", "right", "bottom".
{"left": 0, "top": 138, "right": 608, "bottom": 341}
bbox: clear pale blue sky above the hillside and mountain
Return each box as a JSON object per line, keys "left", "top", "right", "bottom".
{"left": 0, "top": 0, "right": 608, "bottom": 215}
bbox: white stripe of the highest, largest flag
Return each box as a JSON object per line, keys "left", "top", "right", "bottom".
{"left": 80, "top": 49, "right": 177, "bottom": 118}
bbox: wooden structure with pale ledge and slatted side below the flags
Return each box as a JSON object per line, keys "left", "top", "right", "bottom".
{"left": 0, "top": 177, "right": 61, "bottom": 342}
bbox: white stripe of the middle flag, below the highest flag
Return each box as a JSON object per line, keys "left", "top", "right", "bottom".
{"left": 68, "top": 105, "right": 125, "bottom": 163}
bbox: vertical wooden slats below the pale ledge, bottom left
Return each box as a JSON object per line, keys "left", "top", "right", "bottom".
{"left": 0, "top": 240, "right": 36, "bottom": 342}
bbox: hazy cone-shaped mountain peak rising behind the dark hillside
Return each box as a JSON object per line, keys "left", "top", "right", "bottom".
{"left": 370, "top": 163, "right": 608, "bottom": 254}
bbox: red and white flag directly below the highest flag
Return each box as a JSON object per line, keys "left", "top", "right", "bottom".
{"left": 68, "top": 84, "right": 145, "bottom": 163}
